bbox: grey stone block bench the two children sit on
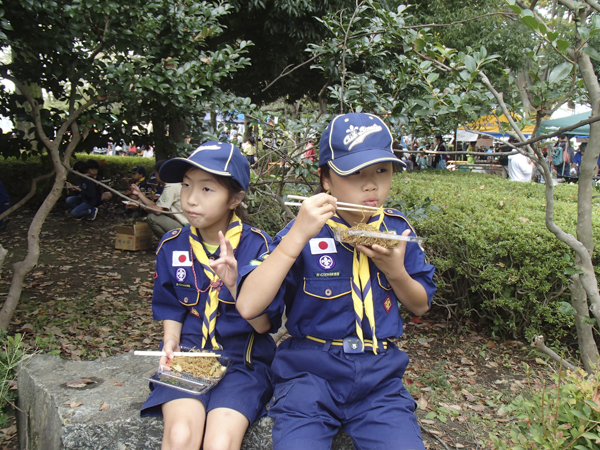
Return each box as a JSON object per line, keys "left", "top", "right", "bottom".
{"left": 17, "top": 354, "right": 354, "bottom": 450}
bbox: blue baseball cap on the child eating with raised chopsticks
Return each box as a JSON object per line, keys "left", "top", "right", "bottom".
{"left": 319, "top": 113, "right": 404, "bottom": 177}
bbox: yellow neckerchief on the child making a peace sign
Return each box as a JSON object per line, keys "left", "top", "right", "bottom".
{"left": 190, "top": 213, "right": 242, "bottom": 350}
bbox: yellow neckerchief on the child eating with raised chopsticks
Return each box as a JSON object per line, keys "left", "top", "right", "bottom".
{"left": 327, "top": 207, "right": 384, "bottom": 354}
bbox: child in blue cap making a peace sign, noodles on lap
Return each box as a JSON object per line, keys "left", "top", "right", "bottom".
{"left": 142, "top": 141, "right": 282, "bottom": 449}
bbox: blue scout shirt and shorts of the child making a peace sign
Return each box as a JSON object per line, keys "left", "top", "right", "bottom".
{"left": 141, "top": 224, "right": 282, "bottom": 423}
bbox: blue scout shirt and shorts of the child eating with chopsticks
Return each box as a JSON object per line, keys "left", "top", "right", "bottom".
{"left": 258, "top": 209, "right": 436, "bottom": 450}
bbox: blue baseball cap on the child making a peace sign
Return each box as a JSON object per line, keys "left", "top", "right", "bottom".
{"left": 158, "top": 141, "right": 250, "bottom": 191}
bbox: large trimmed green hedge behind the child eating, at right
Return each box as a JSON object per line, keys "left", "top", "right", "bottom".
{"left": 392, "top": 171, "right": 600, "bottom": 339}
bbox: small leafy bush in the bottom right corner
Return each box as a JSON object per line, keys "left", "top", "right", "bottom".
{"left": 490, "top": 367, "right": 600, "bottom": 450}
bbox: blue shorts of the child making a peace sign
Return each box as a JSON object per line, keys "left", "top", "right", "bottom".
{"left": 140, "top": 333, "right": 276, "bottom": 423}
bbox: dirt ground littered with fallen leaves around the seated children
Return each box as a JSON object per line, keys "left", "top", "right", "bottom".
{"left": 0, "top": 202, "right": 551, "bottom": 449}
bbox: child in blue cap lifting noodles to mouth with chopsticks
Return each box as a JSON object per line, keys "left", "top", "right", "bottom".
{"left": 237, "top": 113, "right": 436, "bottom": 450}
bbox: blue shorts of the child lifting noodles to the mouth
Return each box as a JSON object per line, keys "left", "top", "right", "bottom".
{"left": 267, "top": 338, "right": 425, "bottom": 450}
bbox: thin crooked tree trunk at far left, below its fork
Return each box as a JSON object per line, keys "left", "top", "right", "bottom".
{"left": 0, "top": 166, "right": 67, "bottom": 330}
